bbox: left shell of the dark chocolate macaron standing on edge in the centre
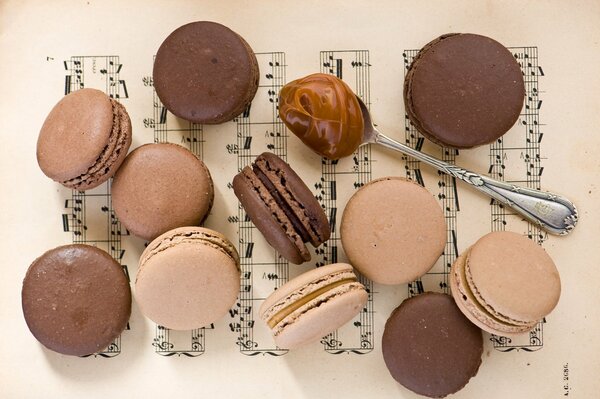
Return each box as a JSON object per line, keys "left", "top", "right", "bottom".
{"left": 233, "top": 167, "right": 310, "bottom": 264}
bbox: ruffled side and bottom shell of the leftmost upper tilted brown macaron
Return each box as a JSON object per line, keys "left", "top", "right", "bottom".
{"left": 62, "top": 98, "right": 131, "bottom": 189}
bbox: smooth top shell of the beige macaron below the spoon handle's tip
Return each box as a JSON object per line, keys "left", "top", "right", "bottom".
{"left": 466, "top": 232, "right": 561, "bottom": 324}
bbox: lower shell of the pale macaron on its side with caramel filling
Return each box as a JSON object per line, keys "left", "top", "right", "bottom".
{"left": 273, "top": 283, "right": 368, "bottom": 349}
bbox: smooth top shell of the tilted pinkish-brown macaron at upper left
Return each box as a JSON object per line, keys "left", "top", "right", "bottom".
{"left": 37, "top": 89, "right": 113, "bottom": 182}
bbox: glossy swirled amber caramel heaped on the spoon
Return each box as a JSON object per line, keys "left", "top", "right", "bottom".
{"left": 279, "top": 73, "right": 364, "bottom": 159}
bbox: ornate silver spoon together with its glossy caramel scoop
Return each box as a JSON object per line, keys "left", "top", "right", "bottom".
{"left": 279, "top": 73, "right": 578, "bottom": 235}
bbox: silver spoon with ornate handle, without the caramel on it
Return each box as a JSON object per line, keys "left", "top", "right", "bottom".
{"left": 356, "top": 96, "right": 577, "bottom": 235}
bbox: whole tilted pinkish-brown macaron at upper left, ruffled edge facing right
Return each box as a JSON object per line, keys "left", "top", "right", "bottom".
{"left": 37, "top": 89, "right": 131, "bottom": 191}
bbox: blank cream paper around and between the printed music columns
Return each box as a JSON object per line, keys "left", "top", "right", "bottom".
{"left": 0, "top": 0, "right": 600, "bottom": 398}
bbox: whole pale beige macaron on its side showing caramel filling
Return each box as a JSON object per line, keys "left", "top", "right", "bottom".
{"left": 258, "top": 263, "right": 368, "bottom": 349}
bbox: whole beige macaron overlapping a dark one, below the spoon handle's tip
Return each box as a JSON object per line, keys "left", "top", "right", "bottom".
{"left": 450, "top": 231, "right": 561, "bottom": 335}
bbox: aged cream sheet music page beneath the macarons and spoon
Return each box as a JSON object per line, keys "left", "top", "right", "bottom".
{"left": 0, "top": 0, "right": 600, "bottom": 399}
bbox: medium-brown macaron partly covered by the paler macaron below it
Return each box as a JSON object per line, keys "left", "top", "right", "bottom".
{"left": 112, "top": 143, "right": 214, "bottom": 241}
